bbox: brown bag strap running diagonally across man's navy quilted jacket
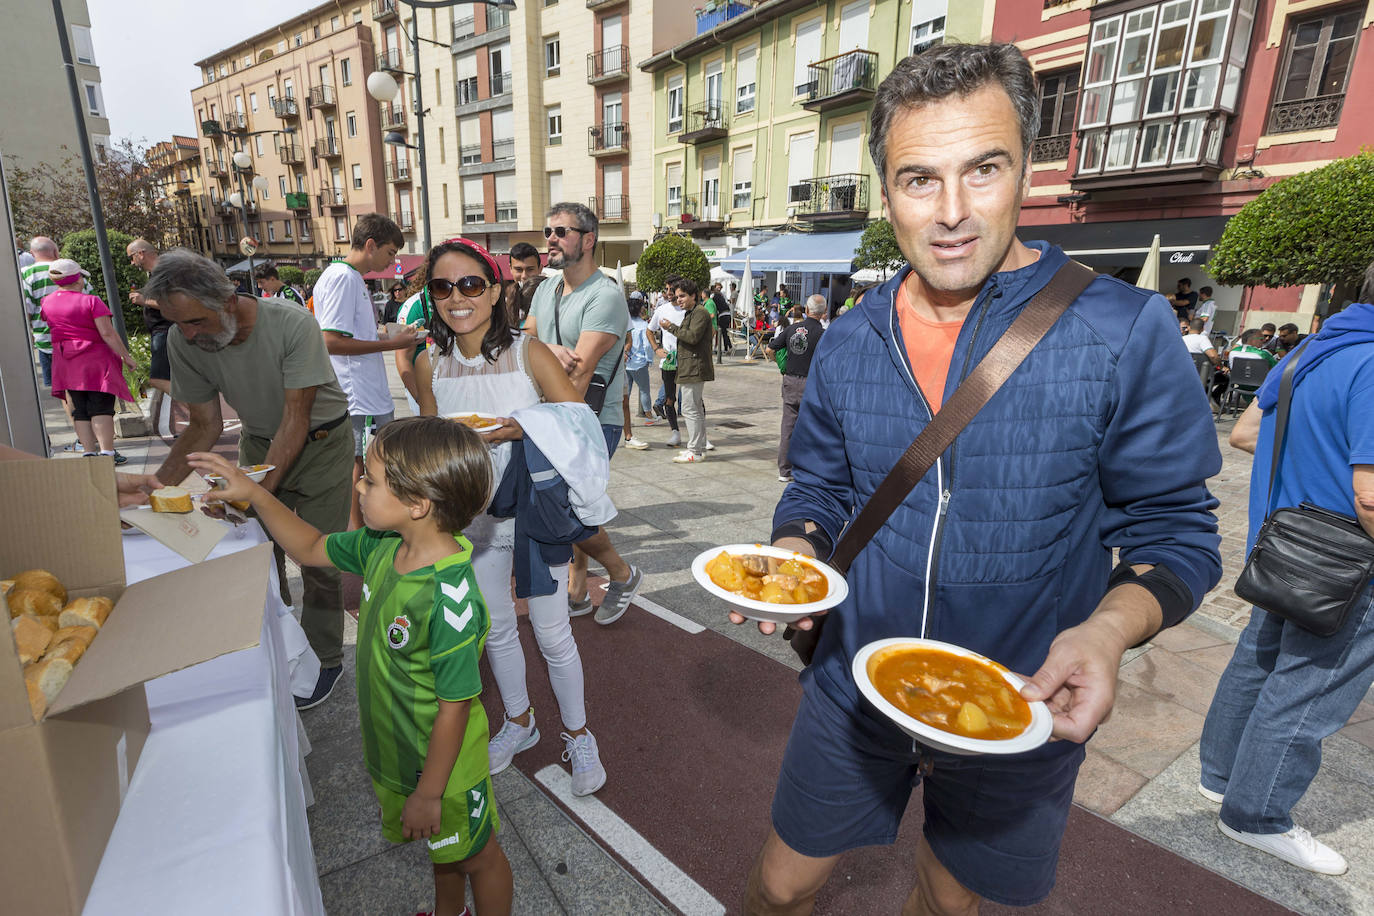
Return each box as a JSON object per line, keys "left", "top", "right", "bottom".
{"left": 783, "top": 261, "right": 1096, "bottom": 665}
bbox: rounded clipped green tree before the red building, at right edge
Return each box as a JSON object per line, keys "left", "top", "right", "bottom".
{"left": 1206, "top": 150, "right": 1374, "bottom": 302}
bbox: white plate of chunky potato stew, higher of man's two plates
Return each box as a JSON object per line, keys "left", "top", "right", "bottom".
{"left": 691, "top": 544, "right": 849, "bottom": 623}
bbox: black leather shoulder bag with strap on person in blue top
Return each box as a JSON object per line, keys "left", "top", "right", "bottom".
{"left": 1235, "top": 338, "right": 1374, "bottom": 636}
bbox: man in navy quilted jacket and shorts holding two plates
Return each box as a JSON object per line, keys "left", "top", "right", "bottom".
{"left": 735, "top": 44, "right": 1221, "bottom": 913}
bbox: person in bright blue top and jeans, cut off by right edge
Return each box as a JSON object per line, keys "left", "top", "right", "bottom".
{"left": 1198, "top": 265, "right": 1374, "bottom": 875}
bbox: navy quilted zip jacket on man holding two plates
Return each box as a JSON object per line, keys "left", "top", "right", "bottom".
{"left": 774, "top": 243, "right": 1221, "bottom": 747}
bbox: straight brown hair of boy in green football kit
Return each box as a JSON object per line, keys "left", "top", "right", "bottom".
{"left": 368, "top": 416, "right": 492, "bottom": 534}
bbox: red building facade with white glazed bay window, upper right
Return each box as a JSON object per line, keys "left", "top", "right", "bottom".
{"left": 992, "top": 0, "right": 1374, "bottom": 331}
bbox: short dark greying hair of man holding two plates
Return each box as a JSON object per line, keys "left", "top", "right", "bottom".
{"left": 868, "top": 44, "right": 1040, "bottom": 190}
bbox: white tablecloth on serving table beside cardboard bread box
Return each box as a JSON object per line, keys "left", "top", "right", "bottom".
{"left": 85, "top": 522, "right": 324, "bottom": 916}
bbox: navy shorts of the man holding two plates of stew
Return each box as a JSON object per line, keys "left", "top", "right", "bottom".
{"left": 772, "top": 684, "right": 1084, "bottom": 906}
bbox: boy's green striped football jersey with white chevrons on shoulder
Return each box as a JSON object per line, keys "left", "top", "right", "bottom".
{"left": 326, "top": 527, "right": 492, "bottom": 795}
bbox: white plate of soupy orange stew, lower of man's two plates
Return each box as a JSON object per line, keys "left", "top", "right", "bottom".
{"left": 852, "top": 637, "right": 1054, "bottom": 754}
